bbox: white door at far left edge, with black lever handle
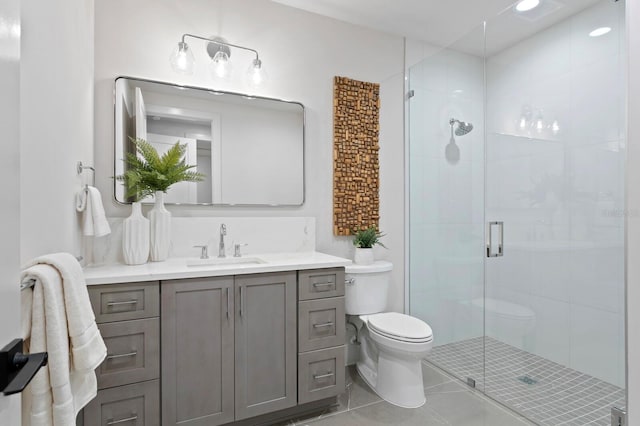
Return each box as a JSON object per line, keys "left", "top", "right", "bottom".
{"left": 0, "top": 0, "right": 20, "bottom": 425}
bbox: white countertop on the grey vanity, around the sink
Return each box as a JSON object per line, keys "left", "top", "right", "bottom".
{"left": 84, "top": 252, "right": 351, "bottom": 285}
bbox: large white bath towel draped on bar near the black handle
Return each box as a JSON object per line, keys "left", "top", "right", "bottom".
{"left": 22, "top": 253, "right": 107, "bottom": 426}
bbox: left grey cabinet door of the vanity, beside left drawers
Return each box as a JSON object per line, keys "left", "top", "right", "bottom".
{"left": 161, "top": 277, "right": 234, "bottom": 426}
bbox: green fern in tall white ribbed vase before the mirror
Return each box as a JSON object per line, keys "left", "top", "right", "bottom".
{"left": 116, "top": 138, "right": 204, "bottom": 261}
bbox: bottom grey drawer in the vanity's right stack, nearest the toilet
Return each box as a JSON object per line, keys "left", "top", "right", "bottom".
{"left": 298, "top": 346, "right": 345, "bottom": 404}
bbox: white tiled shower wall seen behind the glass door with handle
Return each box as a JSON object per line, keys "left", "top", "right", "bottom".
{"left": 486, "top": 2, "right": 626, "bottom": 386}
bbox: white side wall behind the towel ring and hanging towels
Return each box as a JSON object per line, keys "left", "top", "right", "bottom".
{"left": 20, "top": 0, "right": 93, "bottom": 262}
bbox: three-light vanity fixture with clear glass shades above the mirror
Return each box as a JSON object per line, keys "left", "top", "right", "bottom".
{"left": 169, "top": 34, "right": 267, "bottom": 87}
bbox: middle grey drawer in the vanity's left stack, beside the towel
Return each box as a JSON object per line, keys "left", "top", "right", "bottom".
{"left": 96, "top": 318, "right": 160, "bottom": 389}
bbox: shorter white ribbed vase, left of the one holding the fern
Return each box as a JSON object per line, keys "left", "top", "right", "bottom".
{"left": 122, "top": 202, "right": 149, "bottom": 265}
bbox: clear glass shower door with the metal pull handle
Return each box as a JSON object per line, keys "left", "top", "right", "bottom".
{"left": 484, "top": 0, "right": 625, "bottom": 425}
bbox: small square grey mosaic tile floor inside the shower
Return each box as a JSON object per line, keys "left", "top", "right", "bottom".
{"left": 428, "top": 337, "right": 625, "bottom": 426}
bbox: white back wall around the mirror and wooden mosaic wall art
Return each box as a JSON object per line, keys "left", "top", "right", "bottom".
{"left": 95, "top": 0, "right": 404, "bottom": 311}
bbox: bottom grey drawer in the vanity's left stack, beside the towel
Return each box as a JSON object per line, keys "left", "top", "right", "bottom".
{"left": 83, "top": 380, "right": 160, "bottom": 426}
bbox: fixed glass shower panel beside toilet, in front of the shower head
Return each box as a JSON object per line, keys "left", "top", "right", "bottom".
{"left": 408, "top": 22, "right": 485, "bottom": 386}
